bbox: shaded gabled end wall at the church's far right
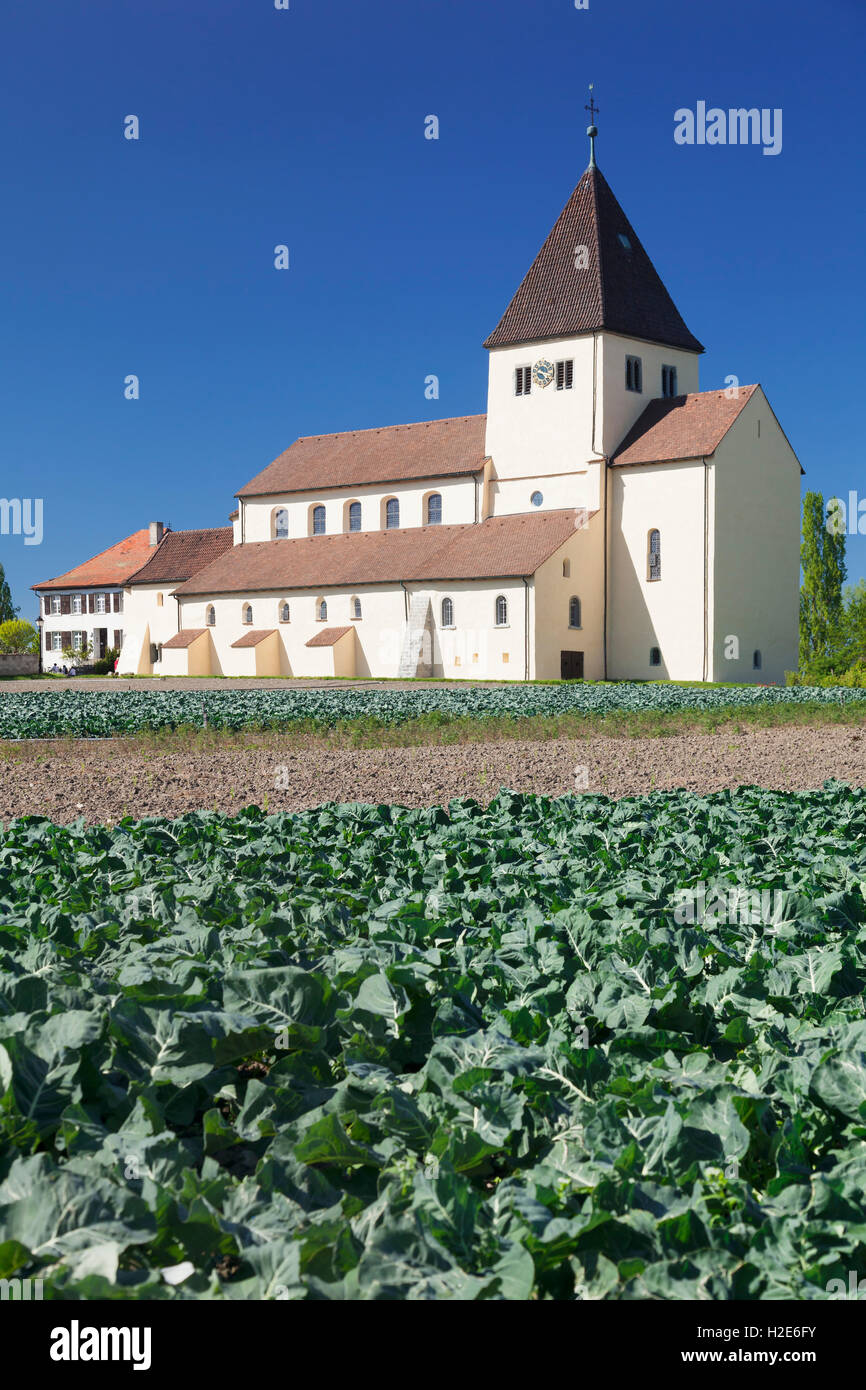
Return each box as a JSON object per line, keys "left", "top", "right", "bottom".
{"left": 712, "top": 389, "right": 801, "bottom": 684}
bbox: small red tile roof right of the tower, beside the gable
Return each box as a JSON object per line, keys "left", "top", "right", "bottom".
{"left": 612, "top": 386, "right": 759, "bottom": 467}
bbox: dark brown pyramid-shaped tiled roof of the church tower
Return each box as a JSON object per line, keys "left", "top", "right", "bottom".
{"left": 484, "top": 167, "right": 703, "bottom": 352}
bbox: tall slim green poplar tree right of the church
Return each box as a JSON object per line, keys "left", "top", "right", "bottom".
{"left": 799, "top": 492, "right": 848, "bottom": 671}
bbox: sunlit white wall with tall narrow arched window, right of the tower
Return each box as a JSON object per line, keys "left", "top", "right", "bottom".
{"left": 607, "top": 460, "right": 712, "bottom": 681}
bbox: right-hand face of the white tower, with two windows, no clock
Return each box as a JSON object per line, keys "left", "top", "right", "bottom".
{"left": 596, "top": 332, "right": 701, "bottom": 455}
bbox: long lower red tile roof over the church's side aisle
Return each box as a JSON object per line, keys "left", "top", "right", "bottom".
{"left": 175, "top": 509, "right": 595, "bottom": 598}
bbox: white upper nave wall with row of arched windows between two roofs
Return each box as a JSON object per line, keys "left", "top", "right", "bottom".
{"left": 240, "top": 474, "right": 477, "bottom": 542}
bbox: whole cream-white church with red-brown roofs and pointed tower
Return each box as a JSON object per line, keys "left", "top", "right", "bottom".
{"left": 38, "top": 128, "right": 802, "bottom": 682}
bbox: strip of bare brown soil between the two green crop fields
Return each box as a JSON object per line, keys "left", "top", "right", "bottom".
{"left": 0, "top": 726, "right": 866, "bottom": 823}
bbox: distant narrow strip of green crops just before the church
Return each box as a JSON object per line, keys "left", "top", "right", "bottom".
{"left": 0, "top": 681, "right": 865, "bottom": 738}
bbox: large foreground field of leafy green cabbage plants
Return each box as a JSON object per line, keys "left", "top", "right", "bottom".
{"left": 0, "top": 789, "right": 866, "bottom": 1301}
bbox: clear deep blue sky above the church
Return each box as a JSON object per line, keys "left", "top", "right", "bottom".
{"left": 0, "top": 0, "right": 866, "bottom": 616}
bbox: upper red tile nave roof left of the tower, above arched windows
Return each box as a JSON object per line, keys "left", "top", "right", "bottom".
{"left": 236, "top": 416, "right": 487, "bottom": 498}
